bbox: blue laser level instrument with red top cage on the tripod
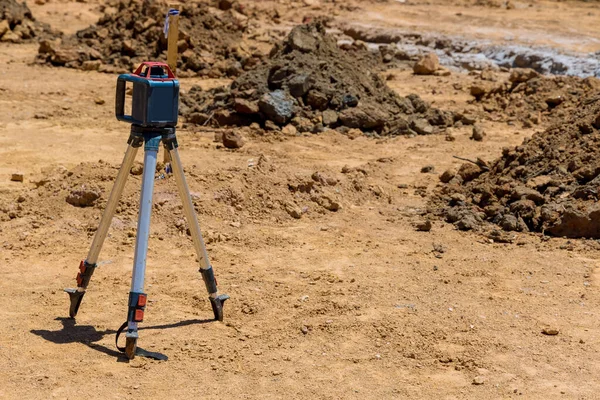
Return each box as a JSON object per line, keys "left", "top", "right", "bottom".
{"left": 115, "top": 61, "right": 179, "bottom": 128}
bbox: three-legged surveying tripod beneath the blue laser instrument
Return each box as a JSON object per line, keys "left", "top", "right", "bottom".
{"left": 65, "top": 124, "right": 229, "bottom": 359}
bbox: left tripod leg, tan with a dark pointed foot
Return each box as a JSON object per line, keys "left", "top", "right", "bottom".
{"left": 65, "top": 136, "right": 142, "bottom": 318}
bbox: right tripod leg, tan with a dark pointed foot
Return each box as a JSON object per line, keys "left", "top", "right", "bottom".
{"left": 168, "top": 141, "right": 229, "bottom": 321}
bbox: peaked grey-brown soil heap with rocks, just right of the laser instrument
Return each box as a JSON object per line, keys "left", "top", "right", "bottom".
{"left": 181, "top": 21, "right": 461, "bottom": 135}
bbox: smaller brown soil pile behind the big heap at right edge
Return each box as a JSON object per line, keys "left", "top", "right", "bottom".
{"left": 471, "top": 68, "right": 600, "bottom": 128}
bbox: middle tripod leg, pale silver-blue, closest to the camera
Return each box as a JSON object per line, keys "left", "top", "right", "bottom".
{"left": 125, "top": 136, "right": 161, "bottom": 359}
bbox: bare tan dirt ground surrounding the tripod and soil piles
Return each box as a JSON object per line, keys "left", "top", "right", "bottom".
{"left": 0, "top": 0, "right": 600, "bottom": 399}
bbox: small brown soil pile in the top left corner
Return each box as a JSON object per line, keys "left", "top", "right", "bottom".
{"left": 0, "top": 0, "right": 54, "bottom": 43}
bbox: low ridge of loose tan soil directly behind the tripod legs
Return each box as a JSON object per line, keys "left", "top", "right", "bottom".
{"left": 0, "top": 155, "right": 394, "bottom": 249}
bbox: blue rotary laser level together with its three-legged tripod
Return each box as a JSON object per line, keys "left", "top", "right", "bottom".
{"left": 65, "top": 62, "right": 229, "bottom": 360}
